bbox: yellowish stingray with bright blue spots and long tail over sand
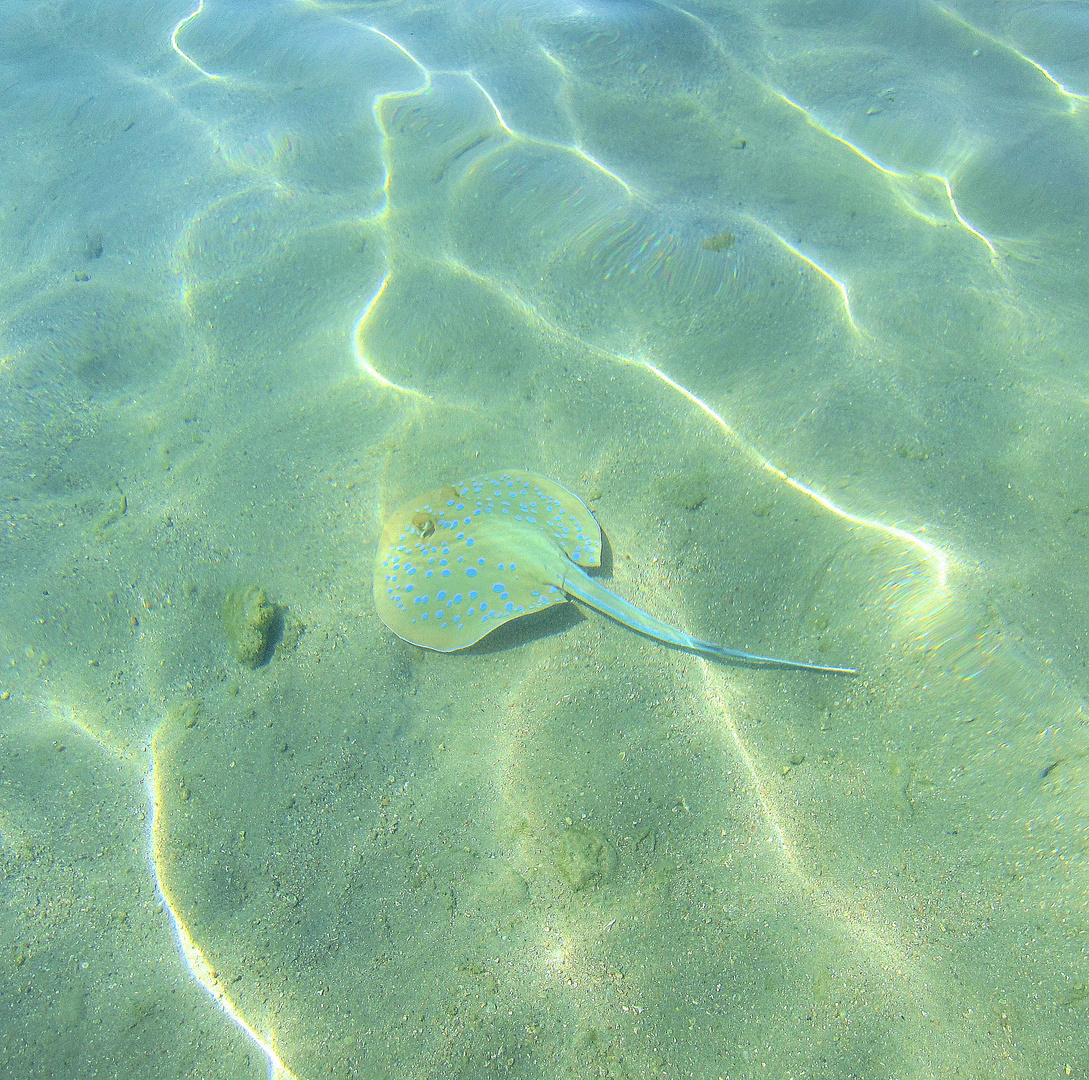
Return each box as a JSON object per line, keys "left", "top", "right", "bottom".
{"left": 375, "top": 469, "right": 855, "bottom": 675}
